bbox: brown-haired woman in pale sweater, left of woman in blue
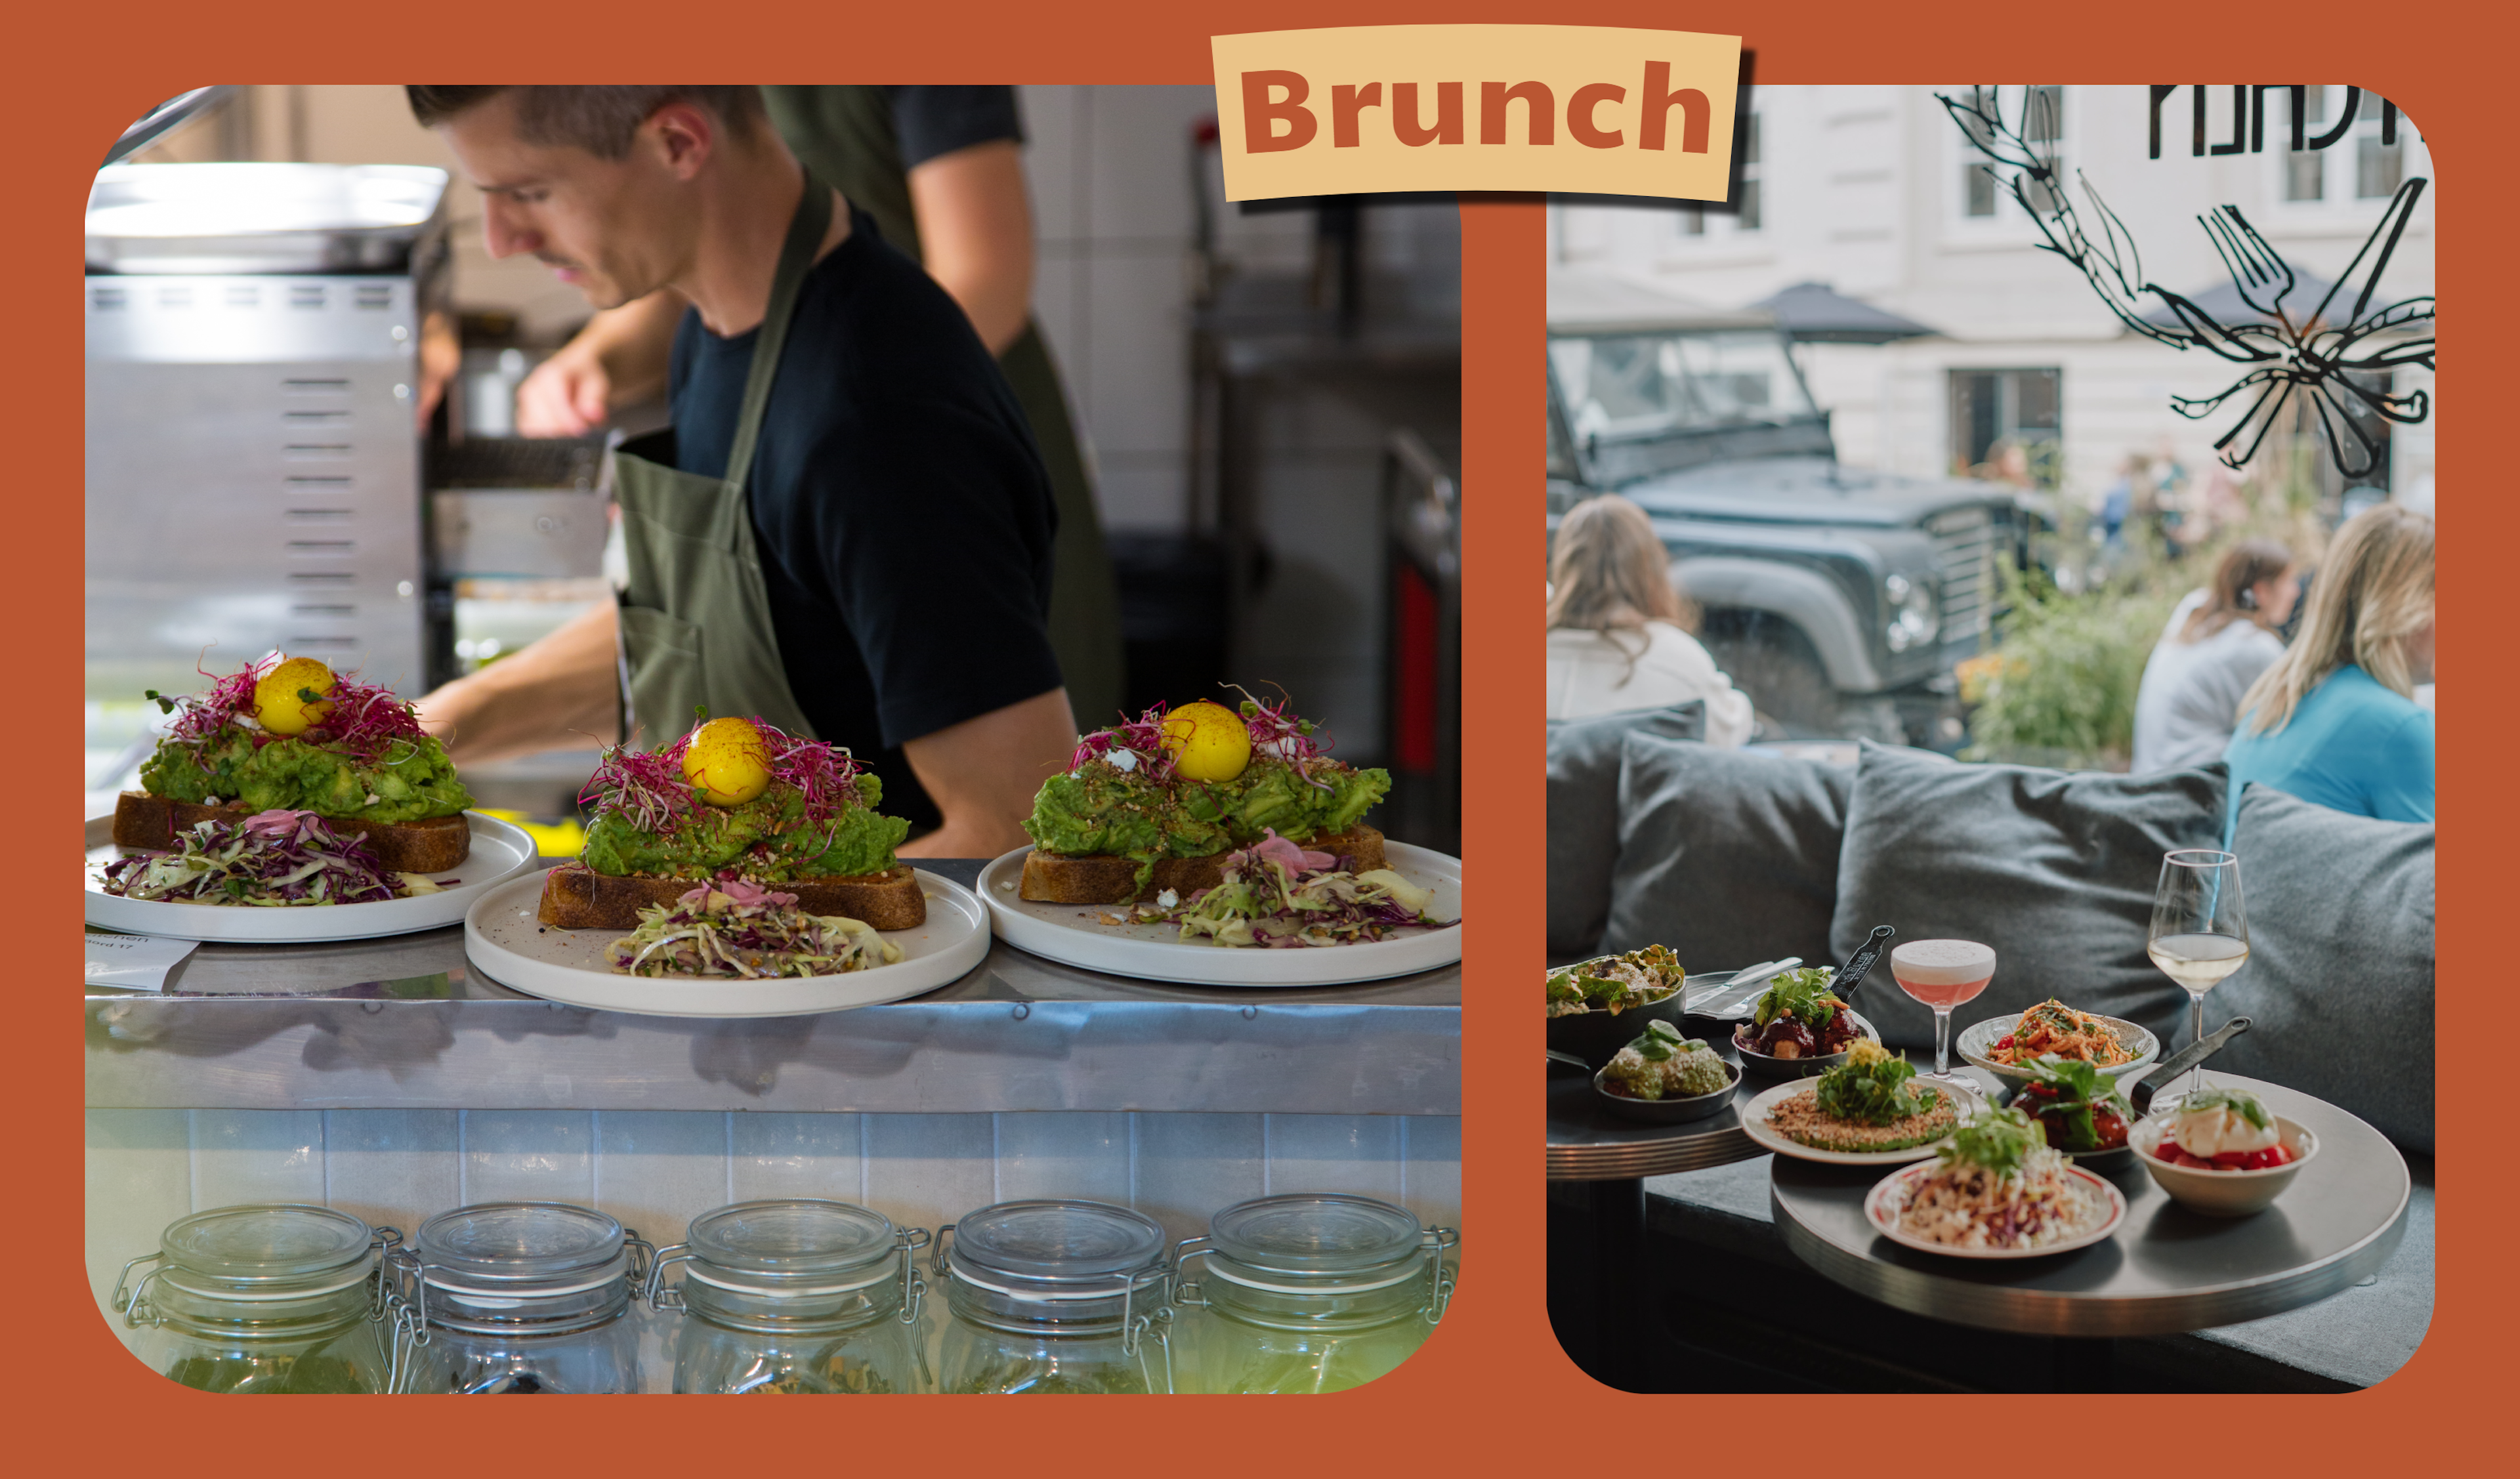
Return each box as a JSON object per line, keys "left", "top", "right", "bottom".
{"left": 2130, "top": 539, "right": 2301, "bottom": 776}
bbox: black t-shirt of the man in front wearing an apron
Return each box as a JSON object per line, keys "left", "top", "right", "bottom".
{"left": 670, "top": 209, "right": 1059, "bottom": 826}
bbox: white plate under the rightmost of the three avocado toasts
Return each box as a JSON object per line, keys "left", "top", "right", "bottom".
{"left": 980, "top": 842, "right": 1461, "bottom": 985}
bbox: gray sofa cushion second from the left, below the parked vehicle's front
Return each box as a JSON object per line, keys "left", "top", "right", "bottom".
{"left": 1600, "top": 733, "right": 1855, "bottom": 970}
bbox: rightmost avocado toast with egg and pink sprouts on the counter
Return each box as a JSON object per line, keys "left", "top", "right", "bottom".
{"left": 1018, "top": 698, "right": 1391, "bottom": 905}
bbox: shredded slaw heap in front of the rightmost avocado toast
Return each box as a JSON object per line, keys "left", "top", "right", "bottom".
{"left": 1111, "top": 831, "right": 1459, "bottom": 950}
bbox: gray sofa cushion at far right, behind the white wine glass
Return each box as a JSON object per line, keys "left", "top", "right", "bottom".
{"left": 2217, "top": 786, "right": 2432, "bottom": 1154}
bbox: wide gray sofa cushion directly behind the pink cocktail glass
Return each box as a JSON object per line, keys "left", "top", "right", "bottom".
{"left": 1830, "top": 743, "right": 2245, "bottom": 1063}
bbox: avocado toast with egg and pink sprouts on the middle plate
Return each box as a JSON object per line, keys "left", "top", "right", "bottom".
{"left": 537, "top": 718, "right": 927, "bottom": 930}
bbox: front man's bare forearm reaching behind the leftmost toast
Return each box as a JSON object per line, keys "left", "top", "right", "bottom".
{"left": 418, "top": 602, "right": 620, "bottom": 763}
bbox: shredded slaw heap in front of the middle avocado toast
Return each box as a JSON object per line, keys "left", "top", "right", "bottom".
{"left": 605, "top": 872, "right": 902, "bottom": 980}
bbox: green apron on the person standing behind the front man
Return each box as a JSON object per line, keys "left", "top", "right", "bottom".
{"left": 761, "top": 86, "right": 1122, "bottom": 728}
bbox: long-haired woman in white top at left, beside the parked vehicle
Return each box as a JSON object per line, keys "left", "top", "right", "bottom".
{"left": 1550, "top": 494, "right": 1752, "bottom": 746}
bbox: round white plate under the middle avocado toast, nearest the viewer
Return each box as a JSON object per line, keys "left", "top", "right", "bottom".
{"left": 464, "top": 869, "right": 988, "bottom": 1018}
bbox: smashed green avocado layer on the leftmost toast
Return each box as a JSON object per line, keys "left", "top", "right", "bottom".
{"left": 141, "top": 726, "right": 471, "bottom": 822}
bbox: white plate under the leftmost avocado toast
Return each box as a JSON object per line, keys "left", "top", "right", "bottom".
{"left": 88, "top": 811, "right": 534, "bottom": 945}
